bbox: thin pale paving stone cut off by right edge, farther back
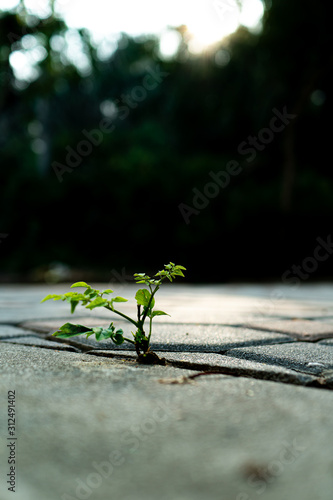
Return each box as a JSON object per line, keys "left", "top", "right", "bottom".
{"left": 243, "top": 319, "right": 333, "bottom": 341}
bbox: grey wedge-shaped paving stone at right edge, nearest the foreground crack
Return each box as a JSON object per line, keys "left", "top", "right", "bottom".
{"left": 222, "top": 342, "right": 333, "bottom": 375}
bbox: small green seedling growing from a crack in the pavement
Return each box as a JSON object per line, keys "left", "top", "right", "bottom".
{"left": 42, "top": 262, "right": 186, "bottom": 364}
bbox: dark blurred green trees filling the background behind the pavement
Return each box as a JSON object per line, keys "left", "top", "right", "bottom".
{"left": 0, "top": 0, "right": 333, "bottom": 282}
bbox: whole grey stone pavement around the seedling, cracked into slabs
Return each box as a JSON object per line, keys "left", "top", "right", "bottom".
{"left": 0, "top": 284, "right": 333, "bottom": 500}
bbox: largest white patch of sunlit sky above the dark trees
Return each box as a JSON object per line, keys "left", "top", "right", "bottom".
{"left": 53, "top": 0, "right": 264, "bottom": 57}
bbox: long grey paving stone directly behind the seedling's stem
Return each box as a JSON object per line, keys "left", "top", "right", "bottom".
{"left": 23, "top": 317, "right": 294, "bottom": 352}
